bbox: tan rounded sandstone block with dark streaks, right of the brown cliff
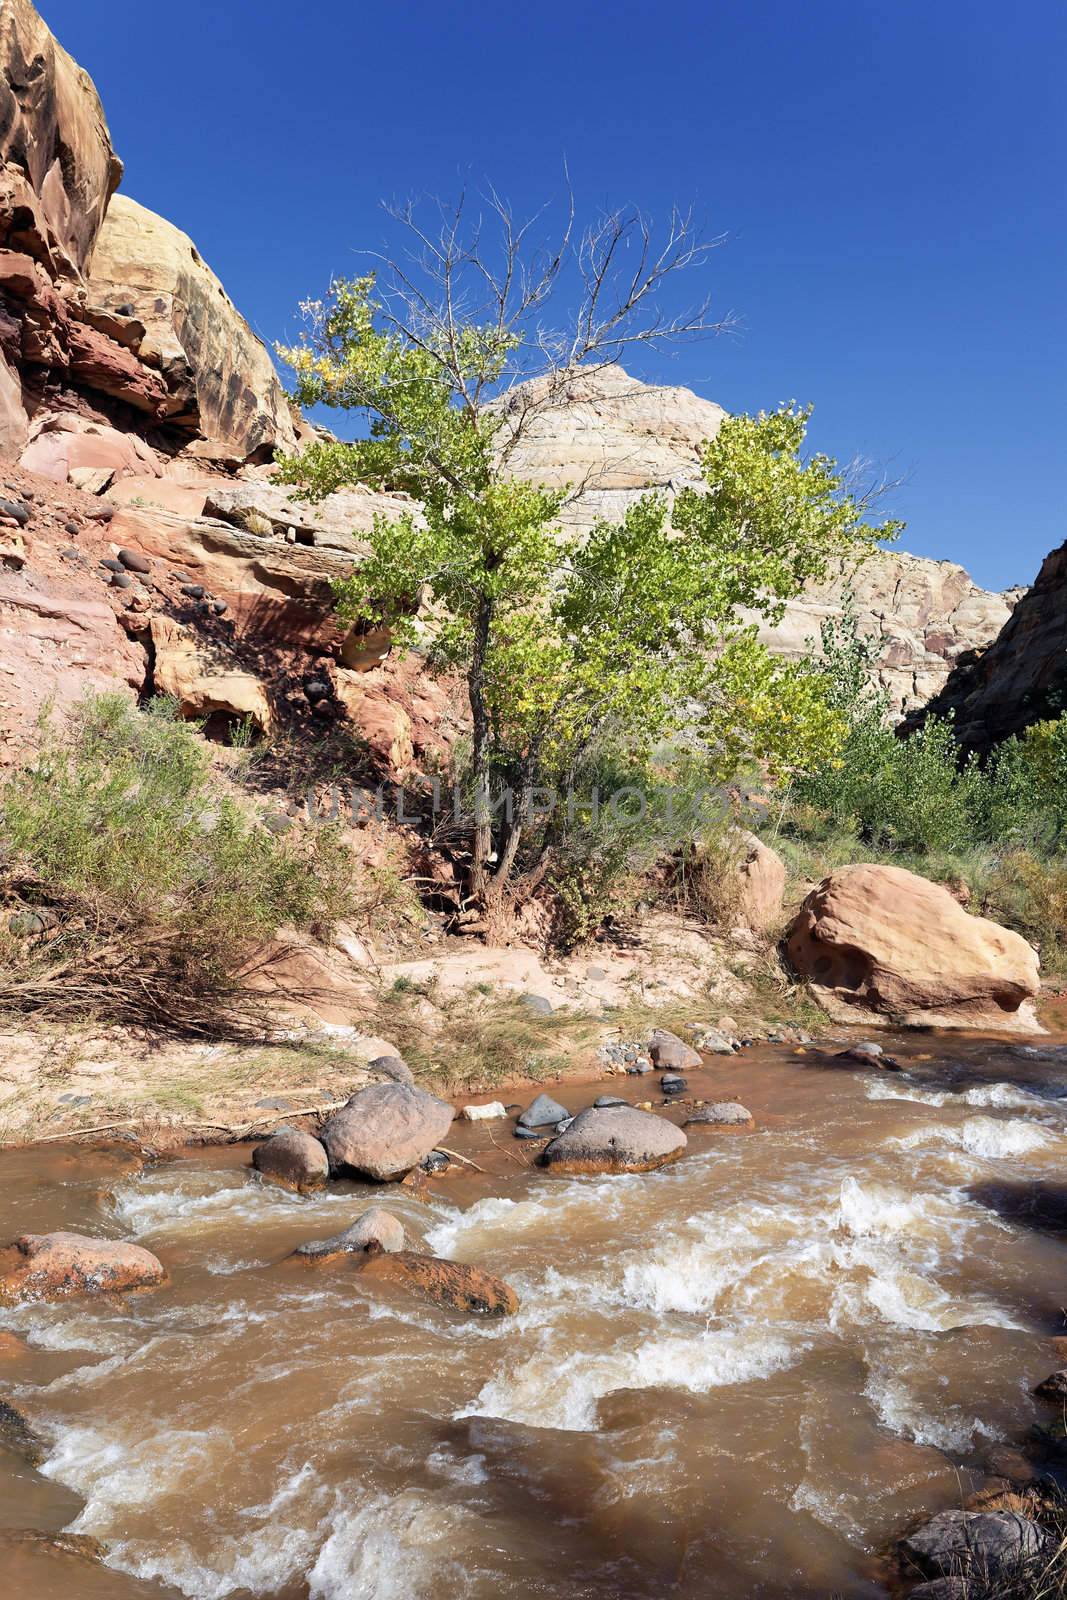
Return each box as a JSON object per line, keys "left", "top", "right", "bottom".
{"left": 88, "top": 195, "right": 296, "bottom": 459}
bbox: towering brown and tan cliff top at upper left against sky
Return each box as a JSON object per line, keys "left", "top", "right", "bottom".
{"left": 0, "top": 0, "right": 296, "bottom": 467}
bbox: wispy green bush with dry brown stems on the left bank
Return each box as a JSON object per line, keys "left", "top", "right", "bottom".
{"left": 0, "top": 694, "right": 352, "bottom": 1034}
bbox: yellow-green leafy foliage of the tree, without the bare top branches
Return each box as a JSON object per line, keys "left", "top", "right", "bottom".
{"left": 282, "top": 265, "right": 897, "bottom": 880}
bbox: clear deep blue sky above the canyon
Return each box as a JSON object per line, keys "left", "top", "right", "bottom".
{"left": 38, "top": 0, "right": 1067, "bottom": 587}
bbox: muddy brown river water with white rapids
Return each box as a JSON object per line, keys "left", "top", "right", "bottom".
{"left": 0, "top": 1038, "right": 1067, "bottom": 1600}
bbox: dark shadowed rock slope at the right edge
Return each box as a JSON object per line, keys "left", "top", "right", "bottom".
{"left": 909, "top": 544, "right": 1067, "bottom": 752}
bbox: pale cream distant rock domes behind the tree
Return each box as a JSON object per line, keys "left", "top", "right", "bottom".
{"left": 507, "top": 365, "right": 1021, "bottom": 710}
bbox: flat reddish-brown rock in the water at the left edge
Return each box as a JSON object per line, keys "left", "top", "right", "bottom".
{"left": 0, "top": 1234, "right": 166, "bottom": 1304}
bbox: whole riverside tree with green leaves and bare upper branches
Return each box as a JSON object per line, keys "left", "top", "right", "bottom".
{"left": 280, "top": 198, "right": 896, "bottom": 899}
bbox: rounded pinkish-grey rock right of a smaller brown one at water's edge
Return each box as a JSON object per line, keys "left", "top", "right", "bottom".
{"left": 322, "top": 1083, "right": 453, "bottom": 1182}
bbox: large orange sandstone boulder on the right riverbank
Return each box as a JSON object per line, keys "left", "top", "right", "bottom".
{"left": 785, "top": 866, "right": 1040, "bottom": 1032}
